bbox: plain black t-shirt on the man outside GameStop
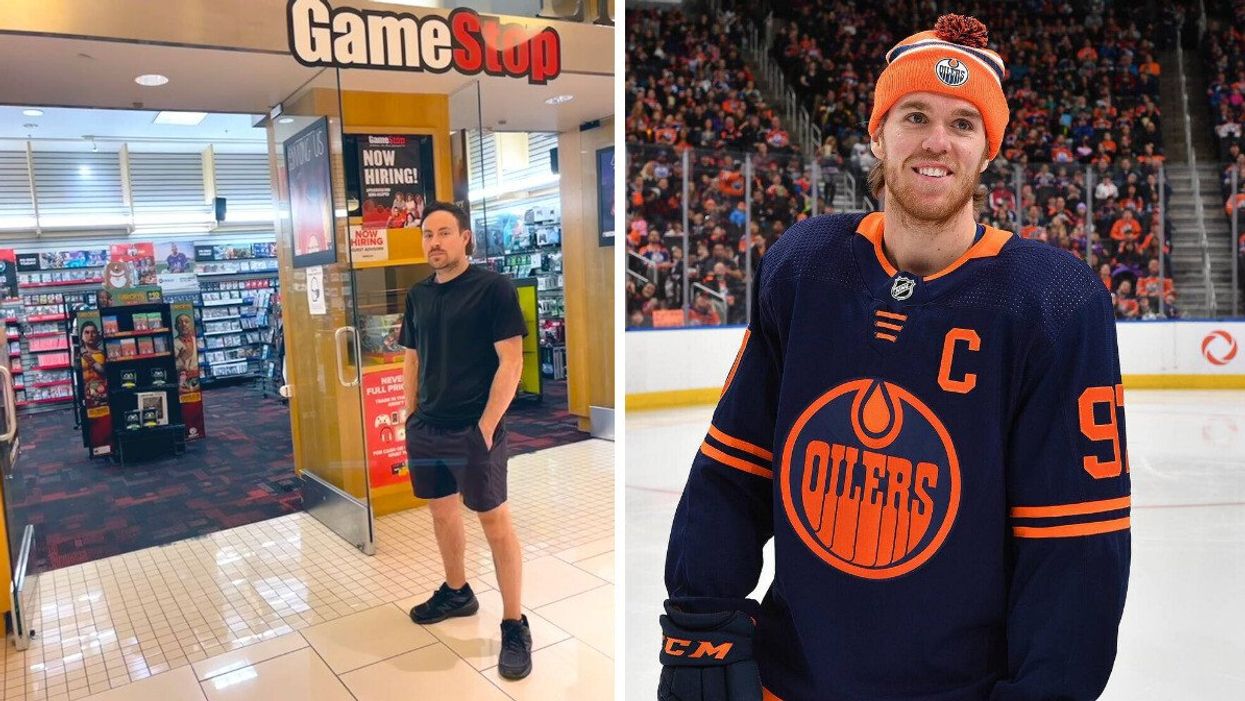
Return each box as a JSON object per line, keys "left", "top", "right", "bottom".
{"left": 402, "top": 268, "right": 528, "bottom": 428}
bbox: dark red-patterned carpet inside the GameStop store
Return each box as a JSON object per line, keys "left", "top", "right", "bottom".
{"left": 5, "top": 381, "right": 589, "bottom": 572}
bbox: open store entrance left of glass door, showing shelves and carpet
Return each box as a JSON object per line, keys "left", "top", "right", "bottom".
{"left": 0, "top": 102, "right": 301, "bottom": 572}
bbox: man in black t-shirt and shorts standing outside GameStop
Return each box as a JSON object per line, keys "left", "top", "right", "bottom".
{"left": 402, "top": 202, "right": 532, "bottom": 679}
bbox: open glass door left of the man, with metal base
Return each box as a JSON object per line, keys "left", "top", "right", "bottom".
{"left": 269, "top": 68, "right": 375, "bottom": 554}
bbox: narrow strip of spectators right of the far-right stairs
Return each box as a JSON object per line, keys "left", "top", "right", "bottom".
{"left": 1205, "top": 0, "right": 1245, "bottom": 298}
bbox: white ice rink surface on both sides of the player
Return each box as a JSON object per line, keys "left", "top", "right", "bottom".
{"left": 625, "top": 390, "right": 1245, "bottom": 701}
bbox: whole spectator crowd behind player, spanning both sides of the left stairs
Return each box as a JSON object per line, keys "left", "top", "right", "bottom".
{"left": 626, "top": 0, "right": 1180, "bottom": 326}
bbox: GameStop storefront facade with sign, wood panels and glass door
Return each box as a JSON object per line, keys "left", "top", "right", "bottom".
{"left": 0, "top": 0, "right": 615, "bottom": 575}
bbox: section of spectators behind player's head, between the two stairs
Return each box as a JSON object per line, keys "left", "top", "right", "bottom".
{"left": 772, "top": 0, "right": 1178, "bottom": 318}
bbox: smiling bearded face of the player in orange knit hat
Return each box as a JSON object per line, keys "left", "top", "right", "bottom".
{"left": 873, "top": 92, "right": 989, "bottom": 222}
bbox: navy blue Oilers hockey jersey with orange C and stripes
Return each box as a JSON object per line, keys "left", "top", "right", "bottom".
{"left": 666, "top": 213, "right": 1129, "bottom": 701}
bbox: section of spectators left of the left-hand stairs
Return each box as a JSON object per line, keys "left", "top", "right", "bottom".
{"left": 626, "top": 9, "right": 812, "bottom": 326}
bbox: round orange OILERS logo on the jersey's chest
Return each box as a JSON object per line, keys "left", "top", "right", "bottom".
{"left": 779, "top": 379, "right": 960, "bottom": 579}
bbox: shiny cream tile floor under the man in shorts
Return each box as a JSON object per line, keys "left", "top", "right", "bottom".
{"left": 0, "top": 440, "right": 614, "bottom": 701}
